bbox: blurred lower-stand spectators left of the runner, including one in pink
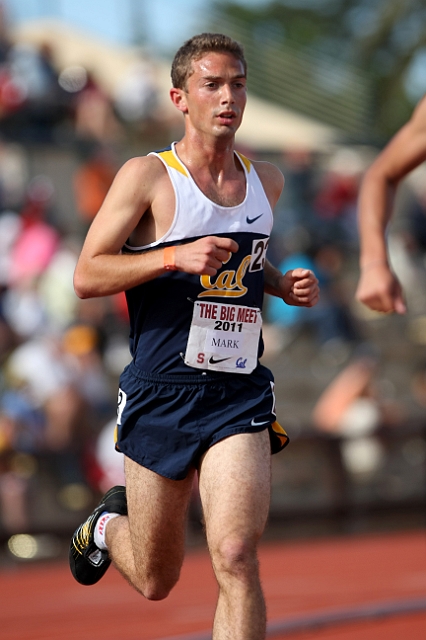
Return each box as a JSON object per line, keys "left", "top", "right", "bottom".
{"left": 0, "top": 154, "right": 129, "bottom": 528}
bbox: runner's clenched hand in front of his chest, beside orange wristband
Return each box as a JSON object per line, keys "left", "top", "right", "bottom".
{"left": 175, "top": 236, "right": 238, "bottom": 276}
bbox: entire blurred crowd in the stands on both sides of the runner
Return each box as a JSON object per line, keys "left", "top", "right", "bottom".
{"left": 0, "top": 5, "right": 426, "bottom": 535}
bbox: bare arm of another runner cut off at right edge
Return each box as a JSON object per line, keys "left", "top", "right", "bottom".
{"left": 356, "top": 97, "right": 426, "bottom": 313}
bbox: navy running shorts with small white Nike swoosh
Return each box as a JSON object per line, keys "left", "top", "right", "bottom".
{"left": 116, "top": 363, "right": 288, "bottom": 480}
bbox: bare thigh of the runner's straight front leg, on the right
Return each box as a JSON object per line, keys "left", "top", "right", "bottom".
{"left": 200, "top": 430, "right": 271, "bottom": 549}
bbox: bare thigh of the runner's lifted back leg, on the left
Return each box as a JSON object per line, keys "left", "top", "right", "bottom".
{"left": 125, "top": 457, "right": 195, "bottom": 573}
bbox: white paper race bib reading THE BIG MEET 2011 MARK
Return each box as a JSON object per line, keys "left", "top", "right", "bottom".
{"left": 184, "top": 301, "right": 262, "bottom": 373}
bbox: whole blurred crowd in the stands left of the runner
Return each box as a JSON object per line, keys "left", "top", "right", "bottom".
{"left": 0, "top": 6, "right": 146, "bottom": 533}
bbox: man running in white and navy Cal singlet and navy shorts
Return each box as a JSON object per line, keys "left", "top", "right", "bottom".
{"left": 70, "top": 34, "right": 318, "bottom": 640}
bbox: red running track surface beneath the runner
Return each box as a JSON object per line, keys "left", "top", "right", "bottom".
{"left": 0, "top": 531, "right": 426, "bottom": 640}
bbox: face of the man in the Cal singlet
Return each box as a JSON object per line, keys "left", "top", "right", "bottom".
{"left": 185, "top": 53, "right": 247, "bottom": 137}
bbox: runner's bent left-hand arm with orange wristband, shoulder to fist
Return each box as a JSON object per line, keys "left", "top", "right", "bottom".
{"left": 74, "top": 157, "right": 238, "bottom": 298}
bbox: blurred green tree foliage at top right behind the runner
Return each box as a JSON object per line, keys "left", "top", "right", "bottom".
{"left": 213, "top": 0, "right": 426, "bottom": 141}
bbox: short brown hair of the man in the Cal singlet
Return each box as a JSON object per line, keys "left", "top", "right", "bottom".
{"left": 171, "top": 33, "right": 247, "bottom": 89}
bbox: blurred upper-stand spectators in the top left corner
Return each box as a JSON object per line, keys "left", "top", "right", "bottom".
{"left": 0, "top": 4, "right": 157, "bottom": 144}
